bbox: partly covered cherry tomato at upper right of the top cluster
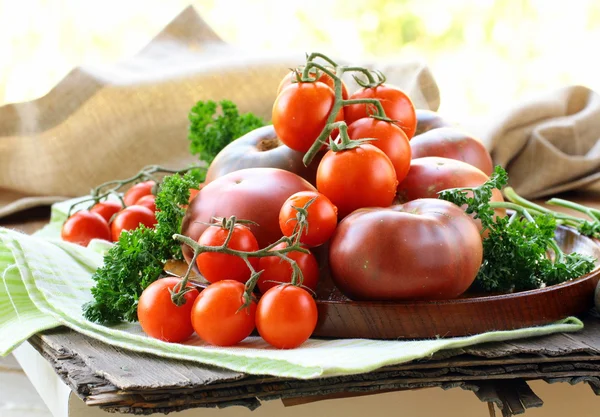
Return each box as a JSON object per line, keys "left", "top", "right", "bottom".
{"left": 344, "top": 84, "right": 417, "bottom": 139}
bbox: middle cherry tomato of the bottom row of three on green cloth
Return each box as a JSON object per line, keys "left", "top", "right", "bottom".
{"left": 192, "top": 280, "right": 256, "bottom": 346}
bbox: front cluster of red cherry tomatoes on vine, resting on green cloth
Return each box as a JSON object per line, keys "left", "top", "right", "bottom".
{"left": 138, "top": 188, "right": 337, "bottom": 349}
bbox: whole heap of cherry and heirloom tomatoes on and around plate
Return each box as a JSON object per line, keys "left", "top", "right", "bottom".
{"left": 63, "top": 53, "right": 502, "bottom": 348}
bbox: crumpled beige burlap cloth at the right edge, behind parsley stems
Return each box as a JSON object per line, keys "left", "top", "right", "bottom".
{"left": 465, "top": 86, "right": 600, "bottom": 198}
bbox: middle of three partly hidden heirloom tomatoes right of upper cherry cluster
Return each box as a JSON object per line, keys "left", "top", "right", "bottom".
{"left": 410, "top": 127, "right": 494, "bottom": 175}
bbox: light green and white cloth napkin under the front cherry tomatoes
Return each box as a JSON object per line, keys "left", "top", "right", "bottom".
{"left": 0, "top": 206, "right": 583, "bottom": 379}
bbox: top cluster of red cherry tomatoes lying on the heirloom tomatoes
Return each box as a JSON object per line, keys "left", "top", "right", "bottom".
{"left": 273, "top": 65, "right": 417, "bottom": 218}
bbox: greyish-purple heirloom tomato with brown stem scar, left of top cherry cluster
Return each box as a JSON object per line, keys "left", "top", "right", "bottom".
{"left": 206, "top": 125, "right": 324, "bottom": 185}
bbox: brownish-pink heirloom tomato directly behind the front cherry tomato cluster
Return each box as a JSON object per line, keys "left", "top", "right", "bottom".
{"left": 181, "top": 168, "right": 316, "bottom": 262}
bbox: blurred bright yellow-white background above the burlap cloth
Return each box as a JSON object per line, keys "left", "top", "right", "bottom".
{"left": 0, "top": 0, "right": 600, "bottom": 118}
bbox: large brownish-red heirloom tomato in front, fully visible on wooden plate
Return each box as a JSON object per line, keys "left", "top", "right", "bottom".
{"left": 329, "top": 199, "right": 483, "bottom": 301}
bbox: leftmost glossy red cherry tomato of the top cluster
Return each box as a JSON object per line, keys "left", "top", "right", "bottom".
{"left": 272, "top": 81, "right": 344, "bottom": 152}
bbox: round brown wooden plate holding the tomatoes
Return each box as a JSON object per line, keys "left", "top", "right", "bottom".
{"left": 313, "top": 227, "right": 600, "bottom": 339}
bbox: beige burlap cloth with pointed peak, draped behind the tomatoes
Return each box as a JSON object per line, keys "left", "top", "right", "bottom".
{"left": 0, "top": 7, "right": 439, "bottom": 217}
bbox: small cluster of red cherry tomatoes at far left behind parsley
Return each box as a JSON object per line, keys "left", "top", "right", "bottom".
{"left": 61, "top": 181, "right": 156, "bottom": 246}
